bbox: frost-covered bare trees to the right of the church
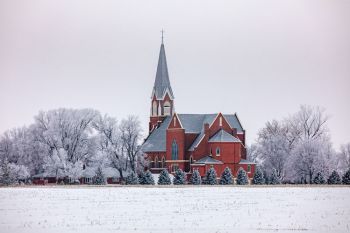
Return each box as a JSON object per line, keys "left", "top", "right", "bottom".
{"left": 248, "top": 106, "right": 350, "bottom": 184}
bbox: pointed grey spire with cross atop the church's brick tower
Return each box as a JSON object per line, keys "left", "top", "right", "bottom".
{"left": 152, "top": 34, "right": 174, "bottom": 99}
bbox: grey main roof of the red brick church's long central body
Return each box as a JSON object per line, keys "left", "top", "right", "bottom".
{"left": 142, "top": 114, "right": 243, "bottom": 152}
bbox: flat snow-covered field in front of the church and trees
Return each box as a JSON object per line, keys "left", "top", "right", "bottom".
{"left": 0, "top": 186, "right": 350, "bottom": 233}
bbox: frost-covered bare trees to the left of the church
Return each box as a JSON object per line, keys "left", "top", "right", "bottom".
{"left": 0, "top": 108, "right": 147, "bottom": 184}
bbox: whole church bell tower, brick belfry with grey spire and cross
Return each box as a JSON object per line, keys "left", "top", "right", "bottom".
{"left": 149, "top": 31, "right": 174, "bottom": 133}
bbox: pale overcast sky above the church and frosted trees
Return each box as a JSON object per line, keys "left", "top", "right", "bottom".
{"left": 0, "top": 0, "right": 350, "bottom": 147}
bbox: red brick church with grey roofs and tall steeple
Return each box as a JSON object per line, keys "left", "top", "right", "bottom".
{"left": 142, "top": 41, "right": 255, "bottom": 178}
